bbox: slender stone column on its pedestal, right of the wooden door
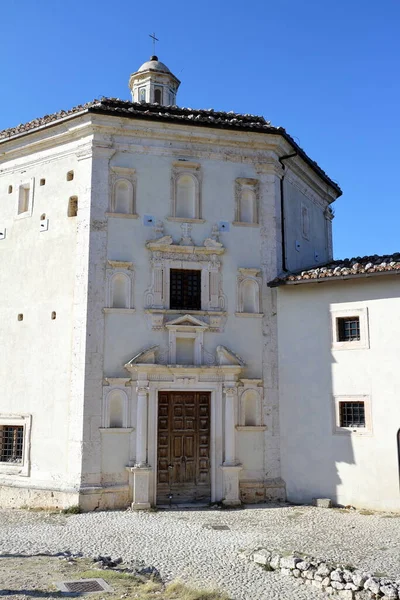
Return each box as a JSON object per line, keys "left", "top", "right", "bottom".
{"left": 222, "top": 384, "right": 242, "bottom": 506}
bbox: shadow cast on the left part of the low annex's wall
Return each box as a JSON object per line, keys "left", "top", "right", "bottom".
{"left": 279, "top": 286, "right": 355, "bottom": 503}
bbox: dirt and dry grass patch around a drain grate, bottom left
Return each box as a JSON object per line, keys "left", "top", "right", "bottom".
{"left": 0, "top": 555, "right": 228, "bottom": 600}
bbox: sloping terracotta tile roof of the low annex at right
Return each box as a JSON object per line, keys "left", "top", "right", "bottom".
{"left": 268, "top": 252, "right": 400, "bottom": 287}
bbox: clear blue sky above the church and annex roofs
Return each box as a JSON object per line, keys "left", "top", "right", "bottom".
{"left": 0, "top": 0, "right": 400, "bottom": 257}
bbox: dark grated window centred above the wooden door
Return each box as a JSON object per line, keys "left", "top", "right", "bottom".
{"left": 170, "top": 269, "right": 201, "bottom": 310}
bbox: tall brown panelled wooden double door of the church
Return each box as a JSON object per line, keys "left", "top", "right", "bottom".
{"left": 157, "top": 392, "right": 211, "bottom": 504}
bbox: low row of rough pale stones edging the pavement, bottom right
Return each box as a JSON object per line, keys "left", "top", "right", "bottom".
{"left": 250, "top": 549, "right": 400, "bottom": 600}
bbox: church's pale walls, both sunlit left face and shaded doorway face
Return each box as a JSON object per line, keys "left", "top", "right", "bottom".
{"left": 0, "top": 114, "right": 340, "bottom": 508}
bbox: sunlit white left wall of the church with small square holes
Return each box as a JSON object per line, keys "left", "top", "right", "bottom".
{"left": 0, "top": 136, "right": 90, "bottom": 496}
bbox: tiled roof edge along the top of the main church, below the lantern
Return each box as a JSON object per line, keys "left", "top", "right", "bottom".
{"left": 0, "top": 98, "right": 342, "bottom": 195}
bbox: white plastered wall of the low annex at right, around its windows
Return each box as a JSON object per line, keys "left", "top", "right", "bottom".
{"left": 278, "top": 276, "right": 400, "bottom": 510}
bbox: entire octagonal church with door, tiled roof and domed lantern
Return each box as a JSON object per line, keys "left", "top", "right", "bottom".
{"left": 0, "top": 57, "right": 396, "bottom": 510}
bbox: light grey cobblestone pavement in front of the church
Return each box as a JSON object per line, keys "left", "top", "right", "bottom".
{"left": 0, "top": 505, "right": 400, "bottom": 600}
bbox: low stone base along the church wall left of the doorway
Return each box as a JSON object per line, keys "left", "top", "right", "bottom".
{"left": 0, "top": 485, "right": 132, "bottom": 512}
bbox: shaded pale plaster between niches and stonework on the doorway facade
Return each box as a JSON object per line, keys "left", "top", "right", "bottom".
{"left": 88, "top": 128, "right": 279, "bottom": 502}
